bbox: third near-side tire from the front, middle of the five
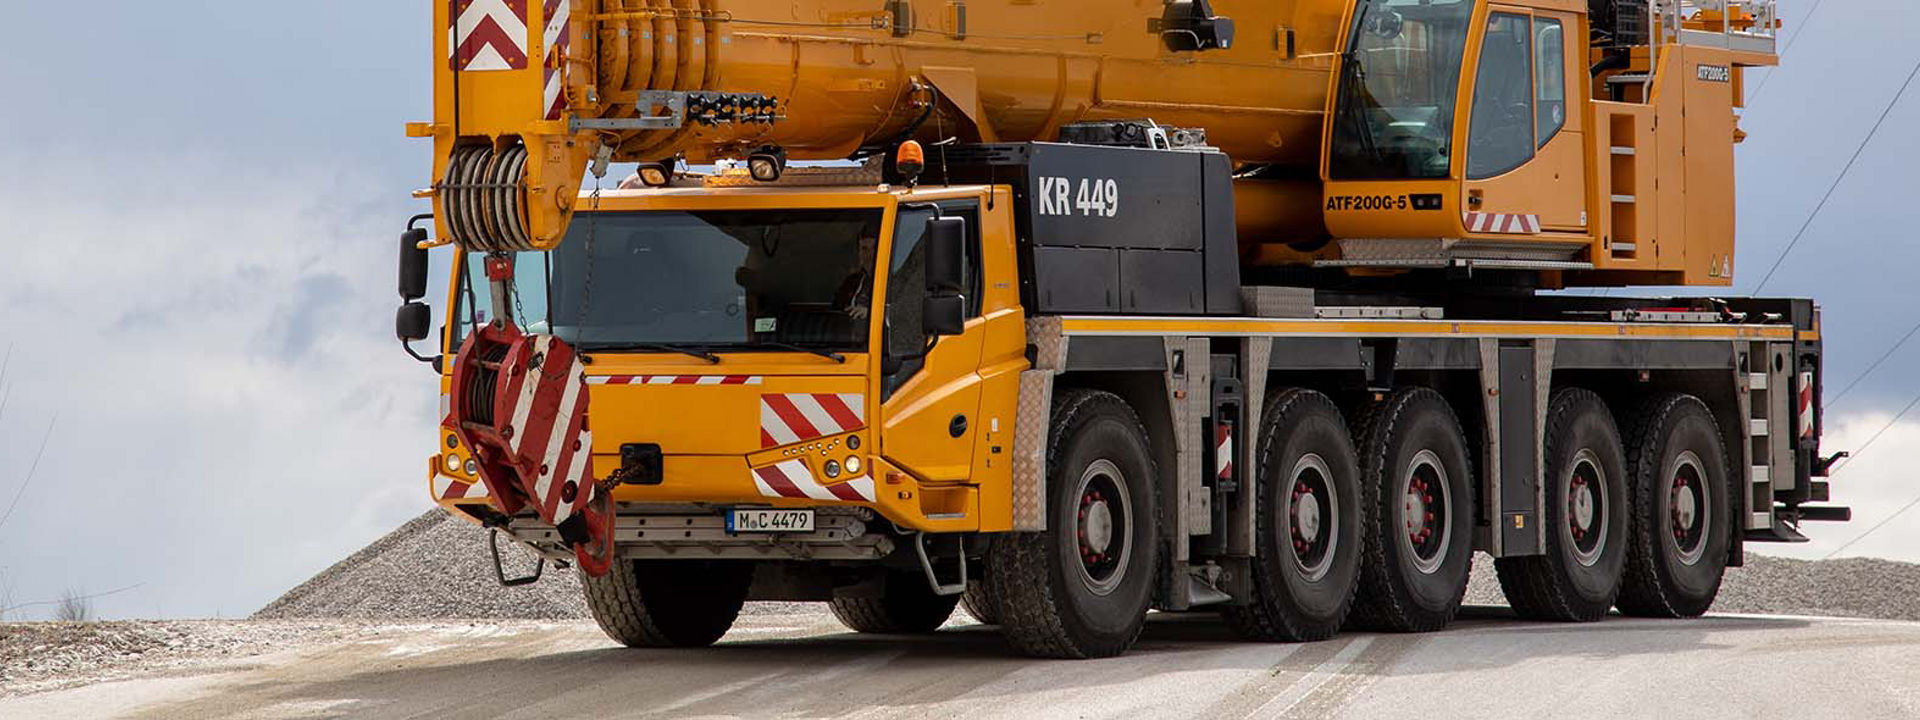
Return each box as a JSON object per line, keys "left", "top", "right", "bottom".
{"left": 1354, "top": 388, "right": 1475, "bottom": 632}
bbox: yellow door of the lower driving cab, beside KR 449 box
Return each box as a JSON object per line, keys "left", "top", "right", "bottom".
{"left": 879, "top": 200, "right": 987, "bottom": 484}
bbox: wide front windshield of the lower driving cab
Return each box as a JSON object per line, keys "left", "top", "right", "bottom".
{"left": 455, "top": 209, "right": 881, "bottom": 351}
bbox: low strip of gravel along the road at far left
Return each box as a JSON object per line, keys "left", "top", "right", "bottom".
{"left": 0, "top": 620, "right": 365, "bottom": 697}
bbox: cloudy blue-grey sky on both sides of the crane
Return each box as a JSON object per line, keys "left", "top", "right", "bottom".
{"left": 0, "top": 0, "right": 1920, "bottom": 618}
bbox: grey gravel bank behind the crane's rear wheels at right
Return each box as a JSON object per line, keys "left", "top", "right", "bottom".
{"left": 1467, "top": 551, "right": 1920, "bottom": 620}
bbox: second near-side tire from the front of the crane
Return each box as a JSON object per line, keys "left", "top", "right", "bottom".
{"left": 1221, "top": 390, "right": 1361, "bottom": 643}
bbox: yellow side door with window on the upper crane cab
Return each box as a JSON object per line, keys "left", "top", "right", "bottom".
{"left": 1461, "top": 6, "right": 1588, "bottom": 234}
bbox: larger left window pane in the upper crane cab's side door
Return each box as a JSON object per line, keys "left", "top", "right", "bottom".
{"left": 1467, "top": 13, "right": 1536, "bottom": 180}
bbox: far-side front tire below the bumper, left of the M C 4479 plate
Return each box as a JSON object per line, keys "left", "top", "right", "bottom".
{"left": 580, "top": 561, "right": 753, "bottom": 647}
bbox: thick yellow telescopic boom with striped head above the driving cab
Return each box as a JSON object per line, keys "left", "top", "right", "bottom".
{"left": 420, "top": 0, "right": 1352, "bottom": 250}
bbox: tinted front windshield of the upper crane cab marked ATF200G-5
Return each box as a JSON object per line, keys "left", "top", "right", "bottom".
{"left": 1327, "top": 0, "right": 1473, "bottom": 180}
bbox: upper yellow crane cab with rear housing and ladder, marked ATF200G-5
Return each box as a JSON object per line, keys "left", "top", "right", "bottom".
{"left": 1319, "top": 0, "right": 1774, "bottom": 284}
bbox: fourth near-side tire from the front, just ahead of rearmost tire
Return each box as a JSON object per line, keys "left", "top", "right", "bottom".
{"left": 1494, "top": 390, "right": 1632, "bottom": 622}
